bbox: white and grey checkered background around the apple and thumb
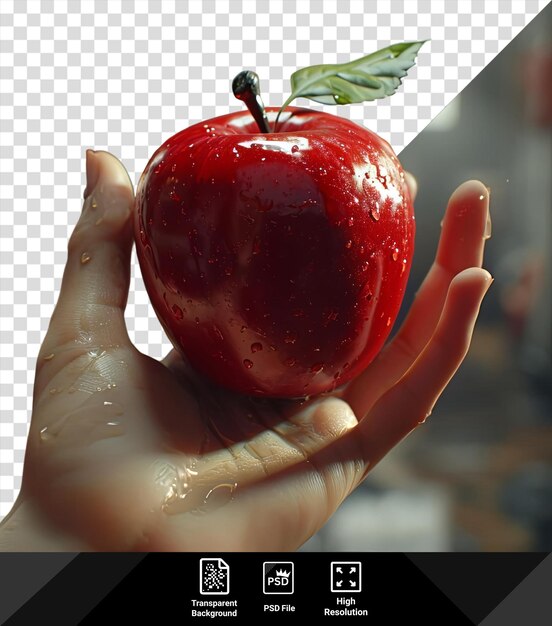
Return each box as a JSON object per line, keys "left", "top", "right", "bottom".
{"left": 0, "top": 0, "right": 547, "bottom": 517}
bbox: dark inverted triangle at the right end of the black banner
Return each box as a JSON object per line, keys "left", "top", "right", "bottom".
{"left": 407, "top": 552, "right": 546, "bottom": 624}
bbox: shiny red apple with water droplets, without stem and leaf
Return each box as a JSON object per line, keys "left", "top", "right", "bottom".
{"left": 135, "top": 107, "right": 415, "bottom": 398}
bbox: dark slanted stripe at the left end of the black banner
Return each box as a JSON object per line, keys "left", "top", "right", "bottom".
{"left": 1, "top": 553, "right": 145, "bottom": 626}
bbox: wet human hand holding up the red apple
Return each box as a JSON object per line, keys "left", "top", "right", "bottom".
{"left": 0, "top": 151, "right": 491, "bottom": 551}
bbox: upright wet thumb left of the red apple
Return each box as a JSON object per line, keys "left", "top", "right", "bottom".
{"left": 39, "top": 150, "right": 134, "bottom": 366}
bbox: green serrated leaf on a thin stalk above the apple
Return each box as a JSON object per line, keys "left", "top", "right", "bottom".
{"left": 275, "top": 41, "right": 425, "bottom": 126}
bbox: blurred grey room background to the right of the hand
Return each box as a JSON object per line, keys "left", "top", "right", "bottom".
{"left": 303, "top": 4, "right": 552, "bottom": 551}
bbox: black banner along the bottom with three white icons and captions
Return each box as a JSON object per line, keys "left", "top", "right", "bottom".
{"left": 0, "top": 552, "right": 552, "bottom": 626}
